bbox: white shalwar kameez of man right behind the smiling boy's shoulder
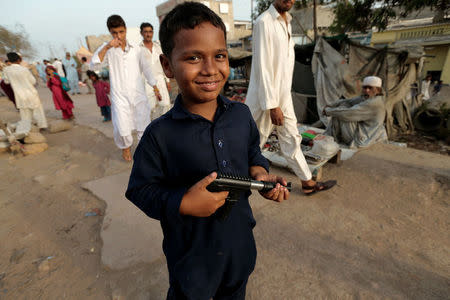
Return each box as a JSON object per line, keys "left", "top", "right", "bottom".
{"left": 139, "top": 41, "right": 171, "bottom": 119}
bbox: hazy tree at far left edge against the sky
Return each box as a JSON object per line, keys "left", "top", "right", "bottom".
{"left": 0, "top": 24, "right": 34, "bottom": 57}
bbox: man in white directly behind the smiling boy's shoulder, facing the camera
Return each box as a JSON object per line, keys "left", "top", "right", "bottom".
{"left": 139, "top": 23, "right": 171, "bottom": 120}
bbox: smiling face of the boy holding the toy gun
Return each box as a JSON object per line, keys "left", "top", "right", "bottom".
{"left": 161, "top": 22, "right": 230, "bottom": 103}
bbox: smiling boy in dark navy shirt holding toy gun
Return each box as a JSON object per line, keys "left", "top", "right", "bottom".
{"left": 126, "top": 2, "right": 289, "bottom": 300}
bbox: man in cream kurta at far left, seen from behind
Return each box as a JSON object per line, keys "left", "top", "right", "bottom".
{"left": 3, "top": 52, "right": 47, "bottom": 128}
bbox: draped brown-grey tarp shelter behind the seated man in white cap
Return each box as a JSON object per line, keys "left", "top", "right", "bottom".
{"left": 293, "top": 36, "right": 424, "bottom": 137}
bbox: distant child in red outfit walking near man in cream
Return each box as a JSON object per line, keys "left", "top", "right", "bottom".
{"left": 45, "top": 66, "right": 74, "bottom": 120}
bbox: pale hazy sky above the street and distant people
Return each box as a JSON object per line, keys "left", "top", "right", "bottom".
{"left": 0, "top": 0, "right": 255, "bottom": 60}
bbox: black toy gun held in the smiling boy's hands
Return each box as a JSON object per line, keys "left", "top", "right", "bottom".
{"left": 207, "top": 174, "right": 292, "bottom": 221}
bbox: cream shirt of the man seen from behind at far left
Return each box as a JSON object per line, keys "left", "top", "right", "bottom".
{"left": 3, "top": 64, "right": 41, "bottom": 109}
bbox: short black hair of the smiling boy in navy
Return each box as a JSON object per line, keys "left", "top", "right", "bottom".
{"left": 159, "top": 2, "right": 227, "bottom": 57}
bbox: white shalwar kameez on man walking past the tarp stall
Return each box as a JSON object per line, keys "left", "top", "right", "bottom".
{"left": 245, "top": 4, "right": 312, "bottom": 180}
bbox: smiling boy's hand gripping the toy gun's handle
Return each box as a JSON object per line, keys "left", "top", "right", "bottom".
{"left": 180, "top": 172, "right": 228, "bottom": 217}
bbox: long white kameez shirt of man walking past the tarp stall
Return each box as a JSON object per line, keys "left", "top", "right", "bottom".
{"left": 245, "top": 4, "right": 295, "bottom": 119}
